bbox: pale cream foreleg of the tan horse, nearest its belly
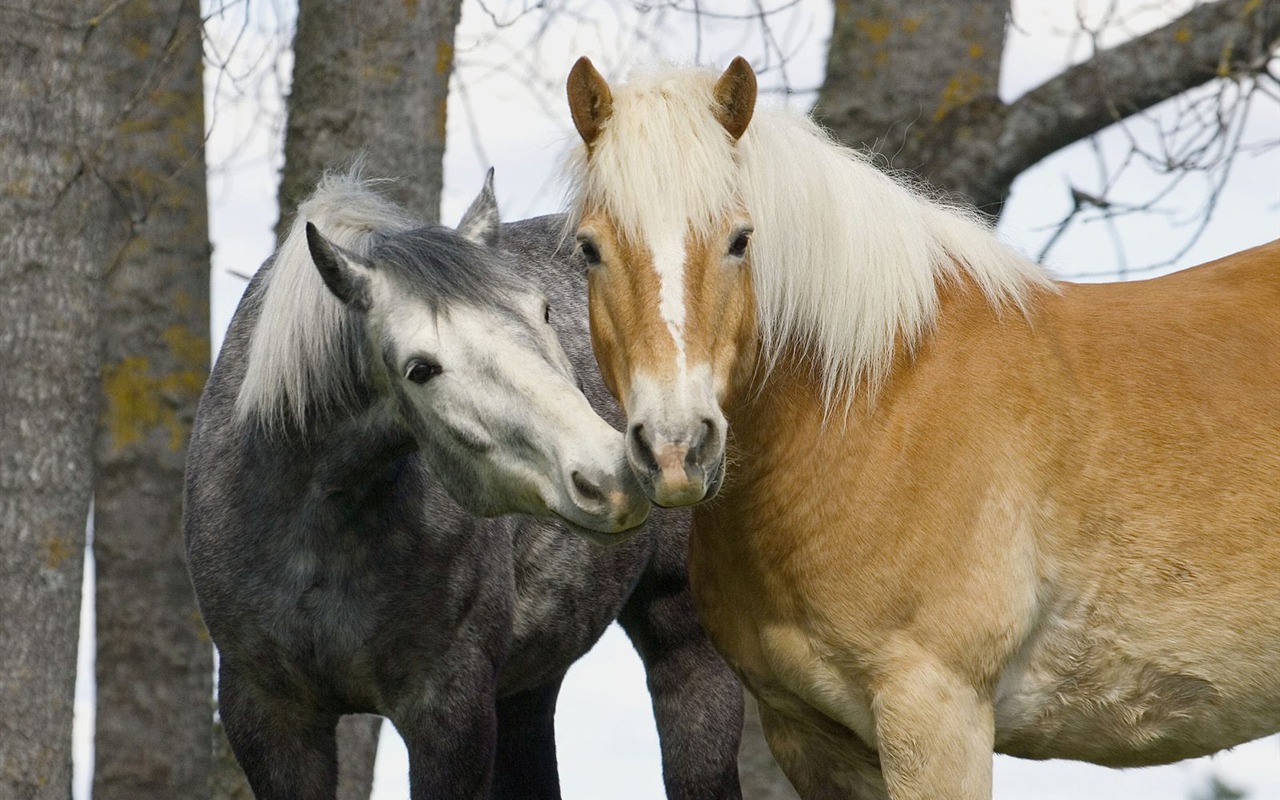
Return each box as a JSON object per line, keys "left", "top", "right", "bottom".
{"left": 872, "top": 655, "right": 995, "bottom": 800}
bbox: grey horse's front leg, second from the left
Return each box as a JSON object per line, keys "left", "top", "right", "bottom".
{"left": 389, "top": 660, "right": 498, "bottom": 800}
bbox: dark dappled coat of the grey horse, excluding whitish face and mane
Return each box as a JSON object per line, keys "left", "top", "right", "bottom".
{"left": 184, "top": 208, "right": 742, "bottom": 800}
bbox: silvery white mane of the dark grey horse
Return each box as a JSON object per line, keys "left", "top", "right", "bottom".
{"left": 236, "top": 165, "right": 421, "bottom": 430}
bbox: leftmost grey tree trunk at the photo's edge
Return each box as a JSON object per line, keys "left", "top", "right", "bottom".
{"left": 0, "top": 0, "right": 111, "bottom": 800}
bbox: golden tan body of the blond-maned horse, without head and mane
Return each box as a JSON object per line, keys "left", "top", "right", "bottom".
{"left": 690, "top": 242, "right": 1280, "bottom": 799}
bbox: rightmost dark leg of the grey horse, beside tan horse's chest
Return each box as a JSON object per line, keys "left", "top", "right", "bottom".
{"left": 618, "top": 548, "right": 744, "bottom": 800}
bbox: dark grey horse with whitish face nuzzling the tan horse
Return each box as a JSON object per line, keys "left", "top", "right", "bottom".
{"left": 184, "top": 172, "right": 742, "bottom": 800}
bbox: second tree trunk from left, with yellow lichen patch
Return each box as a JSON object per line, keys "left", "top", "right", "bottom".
{"left": 93, "top": 0, "right": 212, "bottom": 800}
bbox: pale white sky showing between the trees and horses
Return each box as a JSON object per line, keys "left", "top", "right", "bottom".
{"left": 76, "top": 0, "right": 1280, "bottom": 800}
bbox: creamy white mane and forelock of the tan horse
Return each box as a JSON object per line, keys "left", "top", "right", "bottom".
{"left": 570, "top": 69, "right": 1052, "bottom": 410}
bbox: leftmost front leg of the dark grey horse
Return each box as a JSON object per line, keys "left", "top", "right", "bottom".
{"left": 218, "top": 658, "right": 338, "bottom": 800}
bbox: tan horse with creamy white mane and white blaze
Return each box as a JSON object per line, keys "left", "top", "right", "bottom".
{"left": 568, "top": 59, "right": 1280, "bottom": 800}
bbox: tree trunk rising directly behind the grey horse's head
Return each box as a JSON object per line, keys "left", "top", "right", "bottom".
{"left": 276, "top": 0, "right": 462, "bottom": 234}
